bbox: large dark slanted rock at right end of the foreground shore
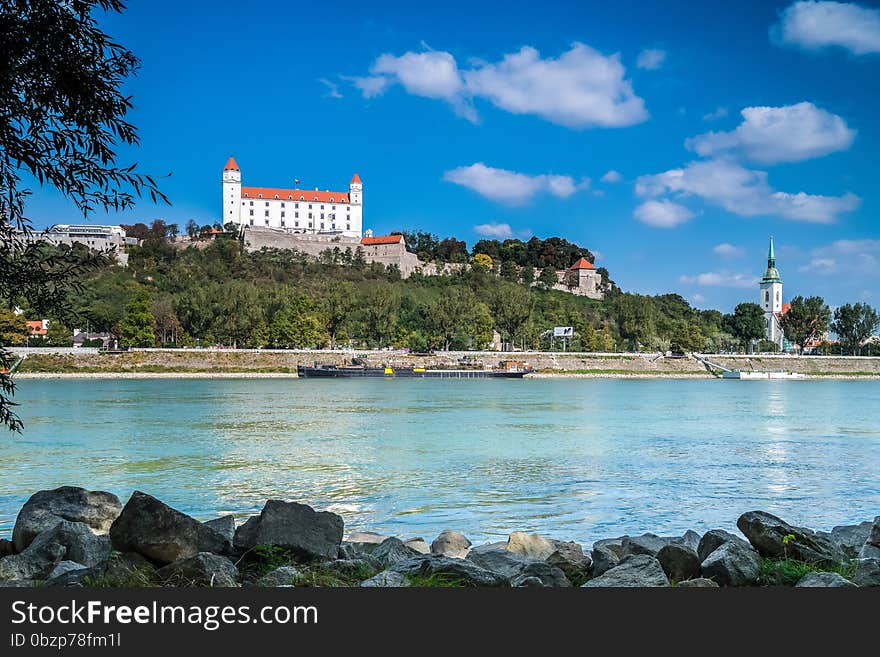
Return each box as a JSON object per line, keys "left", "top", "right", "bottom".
{"left": 736, "top": 511, "right": 847, "bottom": 565}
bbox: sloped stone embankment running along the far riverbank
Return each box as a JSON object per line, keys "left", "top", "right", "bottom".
{"left": 10, "top": 349, "right": 880, "bottom": 379}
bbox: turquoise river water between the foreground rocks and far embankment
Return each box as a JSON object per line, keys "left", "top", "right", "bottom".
{"left": 0, "top": 379, "right": 880, "bottom": 541}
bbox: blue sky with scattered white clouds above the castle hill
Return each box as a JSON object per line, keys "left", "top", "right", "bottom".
{"left": 22, "top": 0, "right": 880, "bottom": 311}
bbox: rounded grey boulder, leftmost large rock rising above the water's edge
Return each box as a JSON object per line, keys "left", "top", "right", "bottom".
{"left": 12, "top": 486, "right": 122, "bottom": 552}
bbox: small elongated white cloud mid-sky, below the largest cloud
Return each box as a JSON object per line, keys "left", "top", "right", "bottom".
{"left": 443, "top": 162, "right": 589, "bottom": 205}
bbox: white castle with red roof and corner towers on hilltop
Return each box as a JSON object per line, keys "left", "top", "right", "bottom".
{"left": 221, "top": 157, "right": 364, "bottom": 239}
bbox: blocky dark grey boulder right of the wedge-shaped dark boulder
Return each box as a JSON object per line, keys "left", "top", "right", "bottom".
{"left": 234, "top": 500, "right": 343, "bottom": 560}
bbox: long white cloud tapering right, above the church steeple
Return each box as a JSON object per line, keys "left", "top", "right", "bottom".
{"left": 636, "top": 160, "right": 861, "bottom": 223}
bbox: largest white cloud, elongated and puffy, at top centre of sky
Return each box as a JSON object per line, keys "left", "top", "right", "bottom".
{"left": 349, "top": 43, "right": 648, "bottom": 128}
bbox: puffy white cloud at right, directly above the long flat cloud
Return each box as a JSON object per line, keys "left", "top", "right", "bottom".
{"left": 685, "top": 102, "right": 856, "bottom": 164}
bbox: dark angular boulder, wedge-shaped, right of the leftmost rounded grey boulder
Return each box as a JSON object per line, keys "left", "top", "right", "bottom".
{"left": 110, "top": 491, "right": 226, "bottom": 565}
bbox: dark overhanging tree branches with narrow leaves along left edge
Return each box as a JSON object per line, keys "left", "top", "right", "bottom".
{"left": 0, "top": 0, "right": 167, "bottom": 430}
